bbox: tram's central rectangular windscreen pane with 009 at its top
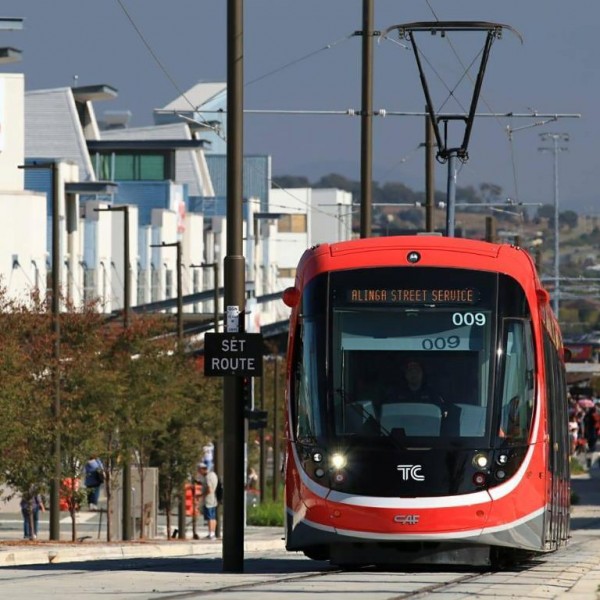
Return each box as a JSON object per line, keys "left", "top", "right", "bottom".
{"left": 332, "top": 307, "right": 493, "bottom": 439}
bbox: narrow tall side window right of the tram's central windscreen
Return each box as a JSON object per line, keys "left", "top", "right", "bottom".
{"left": 499, "top": 319, "right": 534, "bottom": 443}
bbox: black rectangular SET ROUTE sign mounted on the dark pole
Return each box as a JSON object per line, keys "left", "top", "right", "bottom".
{"left": 204, "top": 333, "right": 263, "bottom": 377}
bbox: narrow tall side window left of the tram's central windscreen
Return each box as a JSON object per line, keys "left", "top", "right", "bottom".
{"left": 294, "top": 319, "right": 322, "bottom": 439}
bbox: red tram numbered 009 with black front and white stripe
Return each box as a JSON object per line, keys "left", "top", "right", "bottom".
{"left": 284, "top": 236, "right": 570, "bottom": 565}
